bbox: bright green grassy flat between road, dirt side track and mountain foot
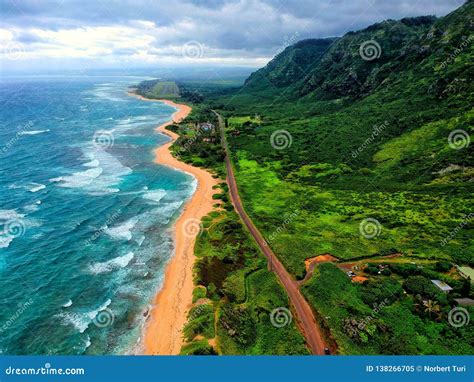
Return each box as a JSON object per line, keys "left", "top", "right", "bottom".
{"left": 231, "top": 151, "right": 473, "bottom": 278}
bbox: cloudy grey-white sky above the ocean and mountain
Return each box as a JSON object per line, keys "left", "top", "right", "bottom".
{"left": 0, "top": 0, "right": 463, "bottom": 71}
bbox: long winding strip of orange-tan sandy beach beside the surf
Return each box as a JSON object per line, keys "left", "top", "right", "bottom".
{"left": 128, "top": 92, "right": 219, "bottom": 355}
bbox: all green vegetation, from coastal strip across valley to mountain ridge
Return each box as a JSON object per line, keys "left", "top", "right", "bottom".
{"left": 139, "top": 1, "right": 474, "bottom": 354}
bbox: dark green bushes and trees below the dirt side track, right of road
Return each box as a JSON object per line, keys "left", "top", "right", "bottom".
{"left": 302, "top": 264, "right": 474, "bottom": 354}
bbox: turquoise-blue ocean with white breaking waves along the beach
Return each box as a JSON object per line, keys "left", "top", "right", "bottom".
{"left": 0, "top": 76, "right": 196, "bottom": 354}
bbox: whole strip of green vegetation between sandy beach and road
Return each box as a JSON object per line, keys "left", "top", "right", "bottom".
{"left": 160, "top": 105, "right": 309, "bottom": 355}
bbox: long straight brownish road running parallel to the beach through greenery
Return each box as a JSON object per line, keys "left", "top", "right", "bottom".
{"left": 214, "top": 111, "right": 326, "bottom": 354}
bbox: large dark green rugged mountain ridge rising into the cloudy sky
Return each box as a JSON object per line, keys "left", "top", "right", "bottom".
{"left": 220, "top": 2, "right": 474, "bottom": 187}
